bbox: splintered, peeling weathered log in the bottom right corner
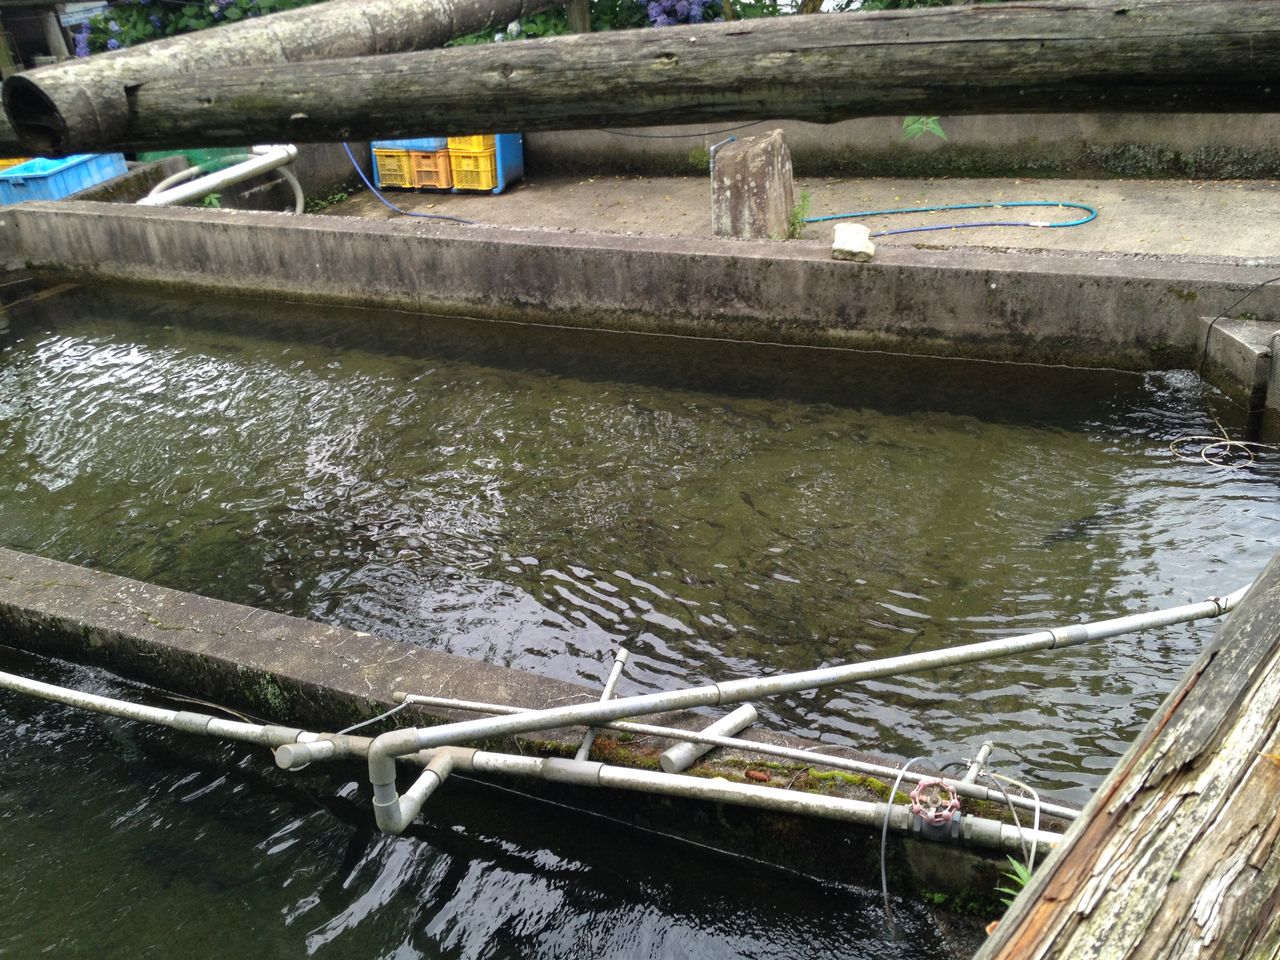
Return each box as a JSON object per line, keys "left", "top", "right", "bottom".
{"left": 975, "top": 557, "right": 1280, "bottom": 960}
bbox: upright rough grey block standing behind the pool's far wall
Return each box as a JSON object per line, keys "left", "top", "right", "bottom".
{"left": 712, "top": 131, "right": 795, "bottom": 239}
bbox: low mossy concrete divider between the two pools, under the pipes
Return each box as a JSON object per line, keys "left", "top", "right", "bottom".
{"left": 0, "top": 548, "right": 1004, "bottom": 901}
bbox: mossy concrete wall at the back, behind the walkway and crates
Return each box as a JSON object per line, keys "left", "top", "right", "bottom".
{"left": 525, "top": 114, "right": 1280, "bottom": 179}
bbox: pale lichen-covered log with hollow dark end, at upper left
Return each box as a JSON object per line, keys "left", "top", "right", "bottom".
{"left": 4, "top": 0, "right": 557, "bottom": 156}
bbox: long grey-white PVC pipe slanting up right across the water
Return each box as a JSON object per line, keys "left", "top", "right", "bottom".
{"left": 369, "top": 586, "right": 1249, "bottom": 764}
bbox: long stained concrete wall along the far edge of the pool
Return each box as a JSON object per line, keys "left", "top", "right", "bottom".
{"left": 0, "top": 201, "right": 1280, "bottom": 369}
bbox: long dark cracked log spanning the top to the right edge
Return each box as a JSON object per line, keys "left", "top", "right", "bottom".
{"left": 77, "top": 0, "right": 1280, "bottom": 150}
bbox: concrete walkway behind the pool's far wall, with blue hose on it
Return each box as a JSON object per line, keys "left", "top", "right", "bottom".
{"left": 325, "top": 177, "right": 1280, "bottom": 265}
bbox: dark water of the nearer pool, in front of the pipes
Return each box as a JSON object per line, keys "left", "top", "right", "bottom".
{"left": 0, "top": 648, "right": 941, "bottom": 960}
